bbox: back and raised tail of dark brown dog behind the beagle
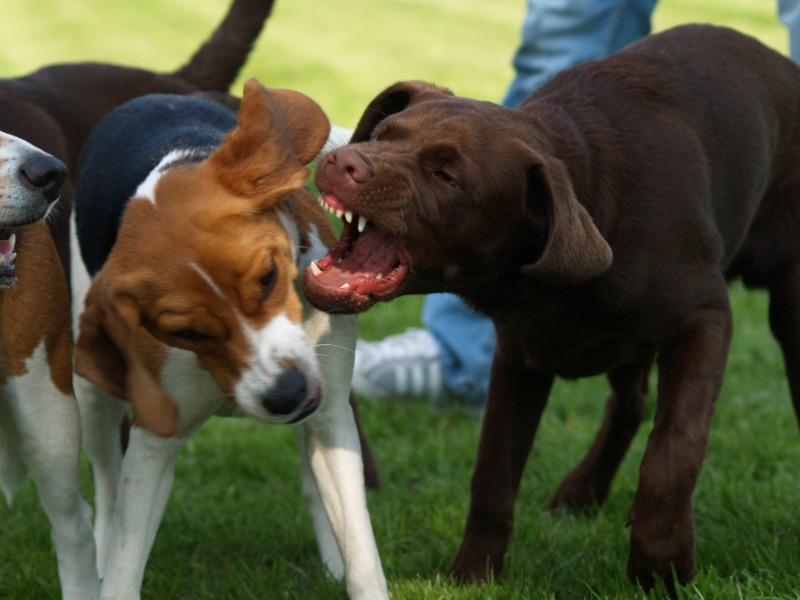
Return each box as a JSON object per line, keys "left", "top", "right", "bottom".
{"left": 0, "top": 0, "right": 274, "bottom": 273}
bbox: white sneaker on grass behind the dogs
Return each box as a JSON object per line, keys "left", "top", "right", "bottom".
{"left": 353, "top": 328, "right": 446, "bottom": 403}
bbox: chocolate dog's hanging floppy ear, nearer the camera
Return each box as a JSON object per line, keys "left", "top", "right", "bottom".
{"left": 520, "top": 158, "right": 613, "bottom": 285}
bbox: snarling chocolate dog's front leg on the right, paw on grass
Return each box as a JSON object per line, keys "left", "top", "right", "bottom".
{"left": 628, "top": 304, "right": 731, "bottom": 595}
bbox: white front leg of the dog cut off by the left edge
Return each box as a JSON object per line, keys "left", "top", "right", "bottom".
{"left": 3, "top": 346, "right": 100, "bottom": 600}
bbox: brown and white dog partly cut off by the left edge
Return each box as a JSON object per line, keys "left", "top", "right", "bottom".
{"left": 0, "top": 133, "right": 99, "bottom": 600}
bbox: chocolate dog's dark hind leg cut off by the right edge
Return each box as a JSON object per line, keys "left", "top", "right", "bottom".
{"left": 769, "top": 265, "right": 800, "bottom": 432}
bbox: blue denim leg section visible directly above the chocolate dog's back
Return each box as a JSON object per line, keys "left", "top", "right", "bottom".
{"left": 503, "top": 0, "right": 656, "bottom": 106}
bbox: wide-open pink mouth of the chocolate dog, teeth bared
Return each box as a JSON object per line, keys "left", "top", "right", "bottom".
{"left": 304, "top": 193, "right": 408, "bottom": 312}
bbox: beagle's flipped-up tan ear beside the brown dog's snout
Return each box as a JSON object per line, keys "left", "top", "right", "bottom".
{"left": 209, "top": 78, "right": 331, "bottom": 206}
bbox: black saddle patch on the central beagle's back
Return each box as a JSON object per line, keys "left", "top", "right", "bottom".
{"left": 75, "top": 94, "right": 236, "bottom": 275}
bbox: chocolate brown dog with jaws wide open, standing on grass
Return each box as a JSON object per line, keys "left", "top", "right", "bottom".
{"left": 305, "top": 26, "right": 800, "bottom": 588}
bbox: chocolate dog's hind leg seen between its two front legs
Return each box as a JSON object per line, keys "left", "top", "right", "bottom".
{"left": 548, "top": 354, "right": 655, "bottom": 511}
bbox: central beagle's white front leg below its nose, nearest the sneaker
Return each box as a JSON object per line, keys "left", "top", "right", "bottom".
{"left": 301, "top": 311, "right": 389, "bottom": 600}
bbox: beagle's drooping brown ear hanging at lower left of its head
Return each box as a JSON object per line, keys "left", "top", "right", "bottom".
{"left": 75, "top": 273, "right": 178, "bottom": 437}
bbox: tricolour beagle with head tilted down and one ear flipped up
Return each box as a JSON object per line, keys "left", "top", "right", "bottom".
{"left": 73, "top": 79, "right": 388, "bottom": 599}
